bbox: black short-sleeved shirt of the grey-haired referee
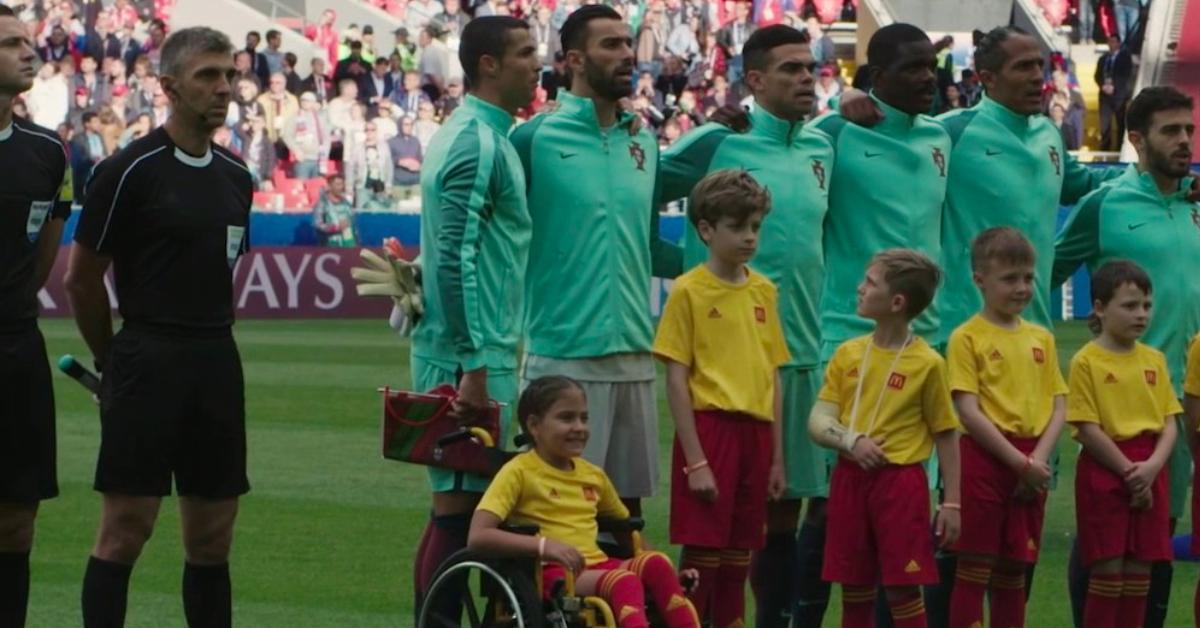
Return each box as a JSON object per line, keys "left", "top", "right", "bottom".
{"left": 74, "top": 127, "right": 253, "bottom": 334}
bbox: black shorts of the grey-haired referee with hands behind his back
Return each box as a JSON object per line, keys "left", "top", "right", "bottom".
{"left": 95, "top": 325, "right": 250, "bottom": 500}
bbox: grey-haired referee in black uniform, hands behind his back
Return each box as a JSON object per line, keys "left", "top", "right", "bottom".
{"left": 66, "top": 28, "right": 252, "bottom": 628}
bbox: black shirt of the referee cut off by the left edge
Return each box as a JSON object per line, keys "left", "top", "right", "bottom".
{"left": 0, "top": 118, "right": 72, "bottom": 325}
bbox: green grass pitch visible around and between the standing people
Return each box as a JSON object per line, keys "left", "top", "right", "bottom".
{"left": 29, "top": 321, "right": 1198, "bottom": 628}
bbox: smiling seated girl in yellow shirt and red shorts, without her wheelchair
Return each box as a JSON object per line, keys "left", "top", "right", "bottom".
{"left": 468, "top": 376, "right": 700, "bottom": 628}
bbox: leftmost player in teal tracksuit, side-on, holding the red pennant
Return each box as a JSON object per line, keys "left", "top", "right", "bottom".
{"left": 412, "top": 16, "right": 539, "bottom": 619}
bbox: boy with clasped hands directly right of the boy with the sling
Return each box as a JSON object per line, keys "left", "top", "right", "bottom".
{"left": 947, "top": 227, "right": 1067, "bottom": 627}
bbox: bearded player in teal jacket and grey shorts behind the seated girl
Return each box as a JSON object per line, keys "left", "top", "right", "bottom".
{"left": 511, "top": 5, "right": 682, "bottom": 516}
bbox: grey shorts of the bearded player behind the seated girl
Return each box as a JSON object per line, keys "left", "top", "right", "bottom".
{"left": 521, "top": 354, "right": 659, "bottom": 498}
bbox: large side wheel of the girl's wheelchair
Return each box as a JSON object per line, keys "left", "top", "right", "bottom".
{"left": 416, "top": 550, "right": 545, "bottom": 628}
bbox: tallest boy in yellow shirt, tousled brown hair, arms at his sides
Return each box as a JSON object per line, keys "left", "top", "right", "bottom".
{"left": 654, "top": 169, "right": 790, "bottom": 628}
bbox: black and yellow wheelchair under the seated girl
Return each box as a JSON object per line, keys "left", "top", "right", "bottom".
{"left": 416, "top": 519, "right": 690, "bottom": 628}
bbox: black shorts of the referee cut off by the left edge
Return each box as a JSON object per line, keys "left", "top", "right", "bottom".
{"left": 0, "top": 321, "right": 59, "bottom": 503}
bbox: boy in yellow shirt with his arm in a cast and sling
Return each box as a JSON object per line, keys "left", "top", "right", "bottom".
{"left": 809, "top": 249, "right": 962, "bottom": 628}
